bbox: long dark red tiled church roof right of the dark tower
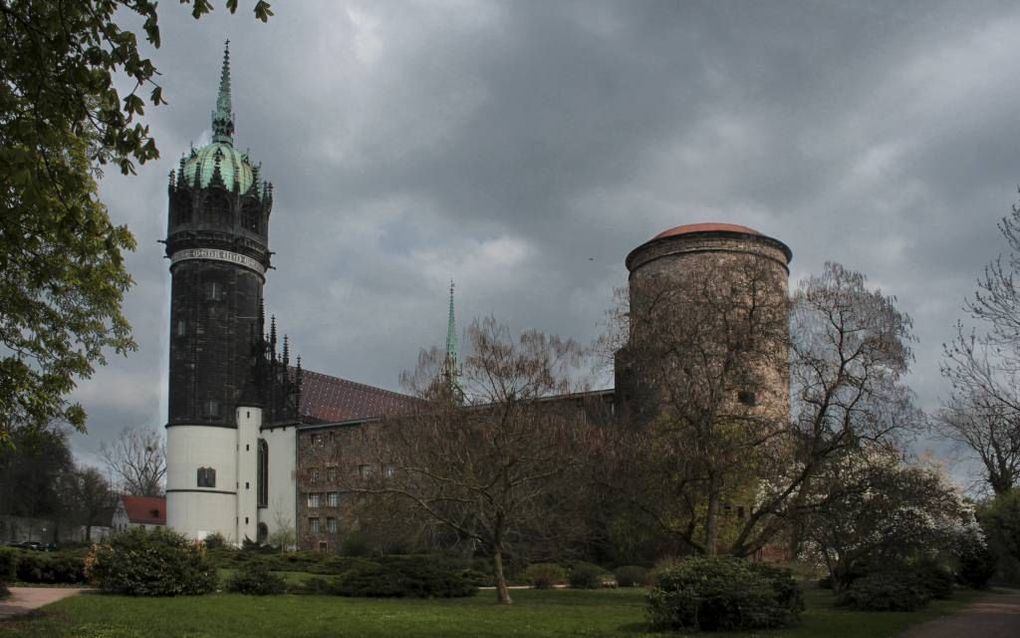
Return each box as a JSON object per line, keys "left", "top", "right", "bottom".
{"left": 301, "top": 370, "right": 419, "bottom": 423}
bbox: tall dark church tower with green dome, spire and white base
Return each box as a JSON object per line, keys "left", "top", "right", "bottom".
{"left": 165, "top": 42, "right": 275, "bottom": 543}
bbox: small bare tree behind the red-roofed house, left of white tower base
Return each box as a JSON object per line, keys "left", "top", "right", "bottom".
{"left": 99, "top": 427, "right": 166, "bottom": 496}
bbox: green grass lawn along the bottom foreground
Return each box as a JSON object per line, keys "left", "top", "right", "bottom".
{"left": 0, "top": 589, "right": 981, "bottom": 638}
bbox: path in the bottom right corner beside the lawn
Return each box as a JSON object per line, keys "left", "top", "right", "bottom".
{"left": 902, "top": 590, "right": 1020, "bottom": 638}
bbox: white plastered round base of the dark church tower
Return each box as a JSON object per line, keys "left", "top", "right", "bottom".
{"left": 166, "top": 426, "right": 239, "bottom": 543}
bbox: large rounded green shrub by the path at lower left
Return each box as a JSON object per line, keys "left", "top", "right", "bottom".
{"left": 86, "top": 528, "right": 217, "bottom": 596}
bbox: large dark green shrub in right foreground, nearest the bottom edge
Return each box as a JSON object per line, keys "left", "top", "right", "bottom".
{"left": 648, "top": 556, "right": 804, "bottom": 631}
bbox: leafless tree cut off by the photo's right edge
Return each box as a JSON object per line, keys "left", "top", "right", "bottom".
{"left": 935, "top": 205, "right": 1020, "bottom": 494}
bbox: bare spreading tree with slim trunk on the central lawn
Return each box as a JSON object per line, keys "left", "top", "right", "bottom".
{"left": 314, "top": 318, "right": 588, "bottom": 604}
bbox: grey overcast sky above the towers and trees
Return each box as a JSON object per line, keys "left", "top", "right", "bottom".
{"left": 73, "top": 0, "right": 1020, "bottom": 481}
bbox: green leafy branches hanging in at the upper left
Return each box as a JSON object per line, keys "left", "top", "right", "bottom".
{"left": 0, "top": 0, "right": 272, "bottom": 442}
